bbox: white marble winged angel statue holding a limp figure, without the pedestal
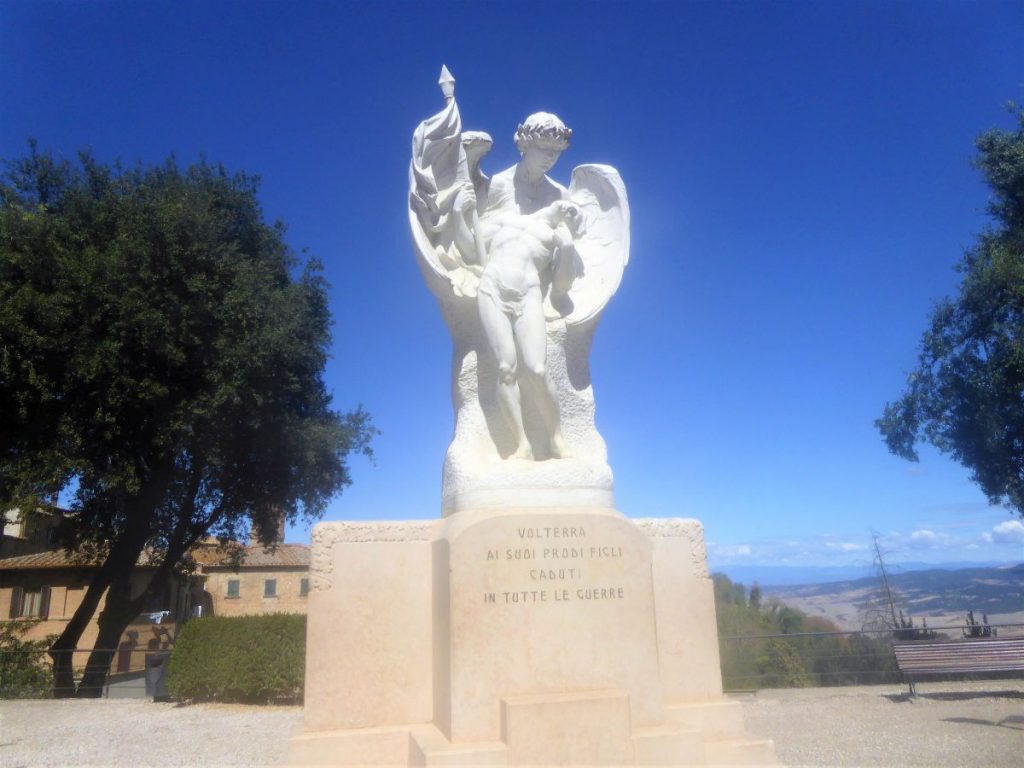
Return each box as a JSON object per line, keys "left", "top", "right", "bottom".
{"left": 409, "top": 68, "right": 630, "bottom": 513}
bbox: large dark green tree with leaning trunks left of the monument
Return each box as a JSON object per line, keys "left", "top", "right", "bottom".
{"left": 0, "top": 144, "right": 375, "bottom": 696}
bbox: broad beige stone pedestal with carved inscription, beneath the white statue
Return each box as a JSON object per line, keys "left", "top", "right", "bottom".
{"left": 290, "top": 508, "right": 774, "bottom": 765}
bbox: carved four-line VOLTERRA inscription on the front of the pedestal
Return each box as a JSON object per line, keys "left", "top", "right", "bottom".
{"left": 483, "top": 525, "right": 626, "bottom": 605}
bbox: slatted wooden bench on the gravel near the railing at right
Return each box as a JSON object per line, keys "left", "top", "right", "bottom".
{"left": 893, "top": 637, "right": 1024, "bottom": 696}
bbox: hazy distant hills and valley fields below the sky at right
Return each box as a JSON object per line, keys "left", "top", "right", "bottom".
{"left": 762, "top": 563, "right": 1024, "bottom": 634}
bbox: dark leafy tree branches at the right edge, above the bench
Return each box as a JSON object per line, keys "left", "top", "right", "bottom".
{"left": 876, "top": 106, "right": 1024, "bottom": 516}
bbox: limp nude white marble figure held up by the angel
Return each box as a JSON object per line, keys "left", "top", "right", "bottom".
{"left": 477, "top": 201, "right": 581, "bottom": 459}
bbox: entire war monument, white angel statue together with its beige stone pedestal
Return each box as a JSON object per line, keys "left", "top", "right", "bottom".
{"left": 290, "top": 70, "right": 774, "bottom": 765}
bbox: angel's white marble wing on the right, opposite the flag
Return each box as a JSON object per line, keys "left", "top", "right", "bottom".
{"left": 565, "top": 164, "right": 630, "bottom": 325}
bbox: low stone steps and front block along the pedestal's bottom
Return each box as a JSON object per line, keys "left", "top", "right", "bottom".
{"left": 286, "top": 690, "right": 777, "bottom": 767}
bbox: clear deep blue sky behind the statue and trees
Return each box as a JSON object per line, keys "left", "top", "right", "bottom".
{"left": 0, "top": 0, "right": 1024, "bottom": 565}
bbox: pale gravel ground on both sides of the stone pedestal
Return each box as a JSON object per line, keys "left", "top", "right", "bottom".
{"left": 0, "top": 680, "right": 1024, "bottom": 768}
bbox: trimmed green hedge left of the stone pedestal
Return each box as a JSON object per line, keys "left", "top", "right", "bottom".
{"left": 167, "top": 613, "right": 306, "bottom": 703}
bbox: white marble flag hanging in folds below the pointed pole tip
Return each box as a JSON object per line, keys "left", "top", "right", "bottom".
{"left": 409, "top": 98, "right": 480, "bottom": 298}
